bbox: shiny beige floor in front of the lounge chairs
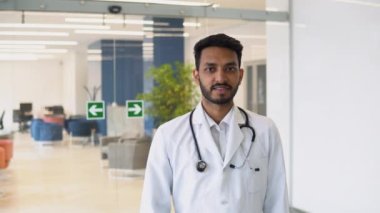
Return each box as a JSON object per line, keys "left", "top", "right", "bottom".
{"left": 0, "top": 134, "right": 143, "bottom": 213}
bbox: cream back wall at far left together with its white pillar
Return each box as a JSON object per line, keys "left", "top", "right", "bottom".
{"left": 0, "top": 48, "right": 88, "bottom": 131}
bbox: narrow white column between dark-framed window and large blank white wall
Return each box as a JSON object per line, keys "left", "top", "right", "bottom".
{"left": 266, "top": 0, "right": 293, "bottom": 205}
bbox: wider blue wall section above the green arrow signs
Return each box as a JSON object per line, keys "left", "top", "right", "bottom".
{"left": 101, "top": 40, "right": 144, "bottom": 135}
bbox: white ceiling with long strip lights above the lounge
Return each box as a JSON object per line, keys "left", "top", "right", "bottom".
{"left": 0, "top": 0, "right": 265, "bottom": 60}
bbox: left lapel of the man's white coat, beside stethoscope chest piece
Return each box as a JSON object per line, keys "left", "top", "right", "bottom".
{"left": 193, "top": 104, "right": 223, "bottom": 164}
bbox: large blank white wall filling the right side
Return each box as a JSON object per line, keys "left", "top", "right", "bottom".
{"left": 293, "top": 0, "right": 380, "bottom": 213}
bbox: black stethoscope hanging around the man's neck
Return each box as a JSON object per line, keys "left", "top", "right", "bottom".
{"left": 189, "top": 107, "right": 256, "bottom": 172}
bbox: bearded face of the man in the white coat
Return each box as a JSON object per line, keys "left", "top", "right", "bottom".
{"left": 193, "top": 47, "right": 243, "bottom": 105}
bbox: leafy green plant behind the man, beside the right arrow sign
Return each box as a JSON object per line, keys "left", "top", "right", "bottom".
{"left": 137, "top": 62, "right": 199, "bottom": 128}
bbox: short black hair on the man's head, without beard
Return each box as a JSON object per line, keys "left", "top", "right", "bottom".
{"left": 194, "top": 33, "right": 243, "bottom": 70}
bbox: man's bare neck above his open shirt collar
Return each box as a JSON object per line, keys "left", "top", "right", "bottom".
{"left": 201, "top": 100, "right": 234, "bottom": 124}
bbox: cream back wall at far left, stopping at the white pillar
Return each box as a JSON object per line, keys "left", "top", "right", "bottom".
{"left": 0, "top": 60, "right": 63, "bottom": 131}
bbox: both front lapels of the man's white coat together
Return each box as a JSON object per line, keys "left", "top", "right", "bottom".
{"left": 193, "top": 103, "right": 245, "bottom": 168}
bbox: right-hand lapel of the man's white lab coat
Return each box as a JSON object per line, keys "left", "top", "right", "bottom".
{"left": 223, "top": 106, "right": 244, "bottom": 168}
